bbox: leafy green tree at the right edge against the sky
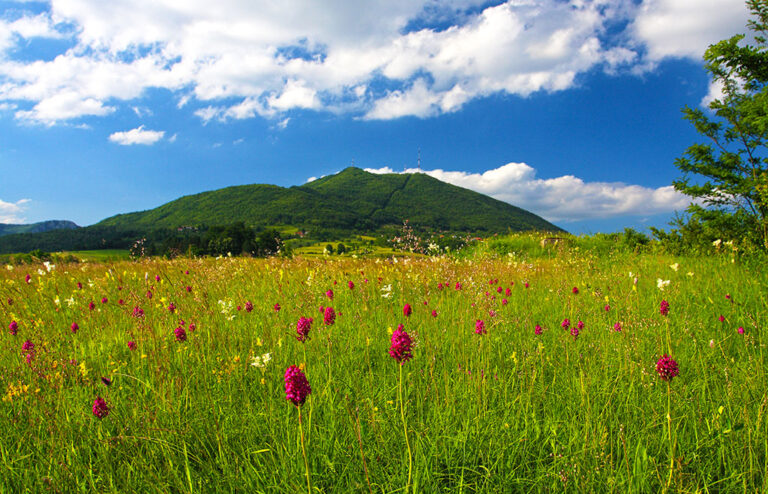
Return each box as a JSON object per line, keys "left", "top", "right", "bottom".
{"left": 673, "top": 0, "right": 768, "bottom": 249}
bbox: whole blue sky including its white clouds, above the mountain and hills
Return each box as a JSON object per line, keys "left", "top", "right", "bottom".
{"left": 0, "top": 0, "right": 748, "bottom": 233}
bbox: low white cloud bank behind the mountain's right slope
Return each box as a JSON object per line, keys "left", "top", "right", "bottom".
{"left": 366, "top": 163, "right": 690, "bottom": 222}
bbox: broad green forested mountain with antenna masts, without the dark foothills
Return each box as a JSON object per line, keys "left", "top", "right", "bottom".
{"left": 95, "top": 168, "right": 562, "bottom": 233}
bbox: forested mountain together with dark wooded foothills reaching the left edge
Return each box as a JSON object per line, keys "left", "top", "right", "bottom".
{"left": 0, "top": 168, "right": 563, "bottom": 253}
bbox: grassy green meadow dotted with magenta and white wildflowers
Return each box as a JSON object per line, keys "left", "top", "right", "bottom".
{"left": 0, "top": 252, "right": 768, "bottom": 493}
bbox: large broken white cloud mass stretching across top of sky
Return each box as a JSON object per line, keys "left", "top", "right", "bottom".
{"left": 0, "top": 0, "right": 747, "bottom": 125}
